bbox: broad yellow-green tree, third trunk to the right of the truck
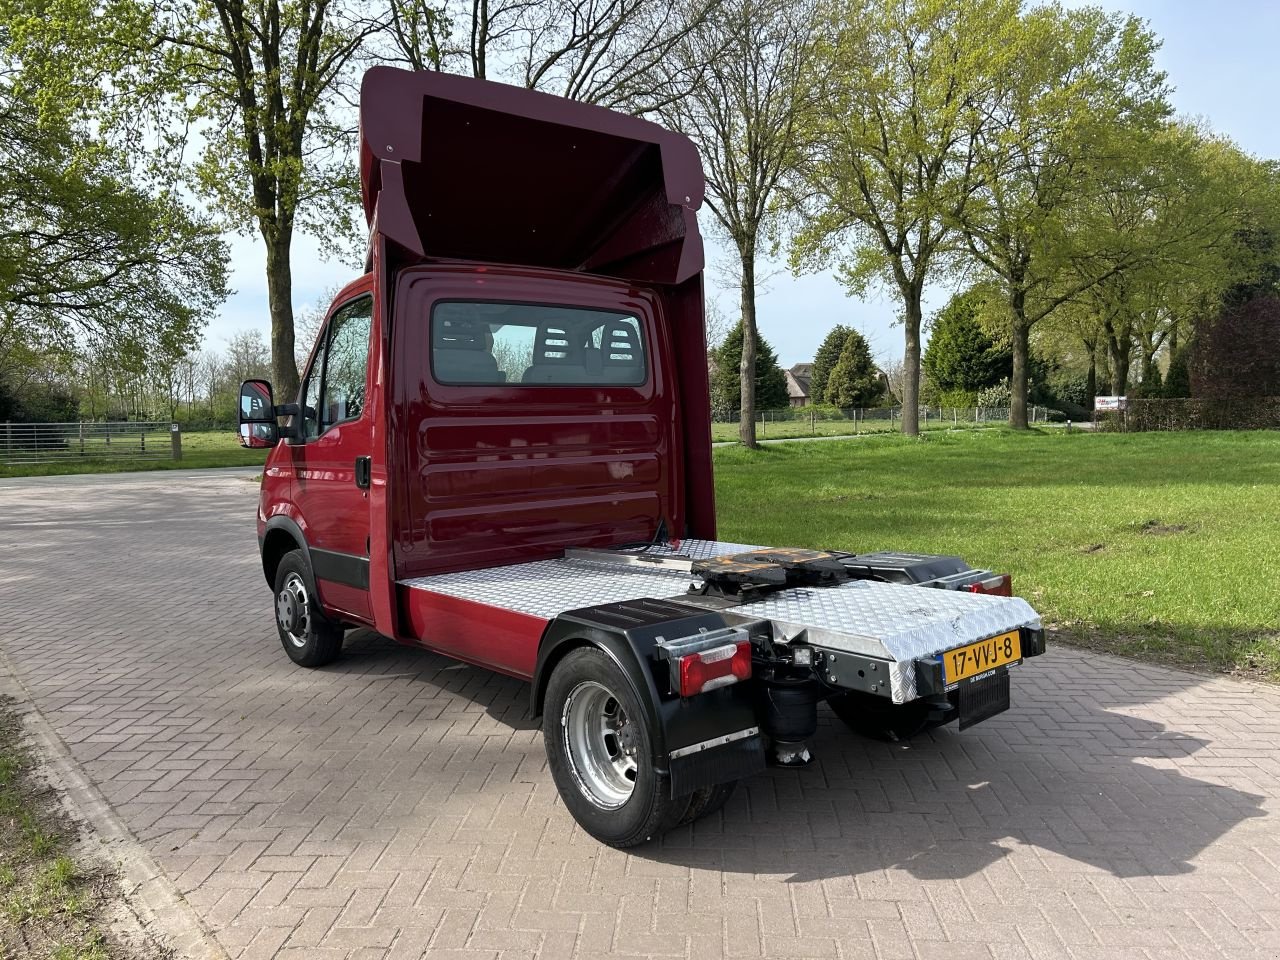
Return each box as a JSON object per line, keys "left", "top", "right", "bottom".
{"left": 960, "top": 6, "right": 1169, "bottom": 429}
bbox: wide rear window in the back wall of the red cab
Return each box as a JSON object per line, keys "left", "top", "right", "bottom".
{"left": 431, "top": 301, "right": 648, "bottom": 387}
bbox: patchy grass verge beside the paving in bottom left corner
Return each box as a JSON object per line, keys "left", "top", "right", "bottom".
{"left": 0, "top": 700, "right": 119, "bottom": 960}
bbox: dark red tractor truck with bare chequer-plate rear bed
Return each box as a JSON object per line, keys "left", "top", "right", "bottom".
{"left": 239, "top": 68, "right": 1044, "bottom": 847}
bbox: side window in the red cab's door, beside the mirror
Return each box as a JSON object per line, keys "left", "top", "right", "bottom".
{"left": 293, "top": 296, "right": 374, "bottom": 440}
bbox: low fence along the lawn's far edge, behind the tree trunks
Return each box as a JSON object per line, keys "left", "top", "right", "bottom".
{"left": 712, "top": 407, "right": 1065, "bottom": 439}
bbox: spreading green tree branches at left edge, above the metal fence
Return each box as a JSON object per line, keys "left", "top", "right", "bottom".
{"left": 0, "top": 67, "right": 227, "bottom": 371}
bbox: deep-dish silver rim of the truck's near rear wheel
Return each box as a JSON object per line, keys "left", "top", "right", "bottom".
{"left": 561, "top": 680, "right": 640, "bottom": 810}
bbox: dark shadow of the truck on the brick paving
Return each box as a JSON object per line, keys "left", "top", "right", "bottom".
{"left": 329, "top": 631, "right": 1263, "bottom": 882}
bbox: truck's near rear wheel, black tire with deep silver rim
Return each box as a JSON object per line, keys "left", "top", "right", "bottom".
{"left": 543, "top": 646, "right": 689, "bottom": 849}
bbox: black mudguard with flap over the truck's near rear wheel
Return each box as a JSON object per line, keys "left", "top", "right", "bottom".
{"left": 531, "top": 599, "right": 764, "bottom": 796}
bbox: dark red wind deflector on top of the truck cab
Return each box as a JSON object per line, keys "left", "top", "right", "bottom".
{"left": 360, "top": 67, "right": 703, "bottom": 283}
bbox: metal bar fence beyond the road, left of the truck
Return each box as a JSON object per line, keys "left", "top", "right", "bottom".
{"left": 0, "top": 421, "right": 182, "bottom": 465}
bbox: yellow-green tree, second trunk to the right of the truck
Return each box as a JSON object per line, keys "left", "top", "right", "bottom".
{"left": 792, "top": 0, "right": 1018, "bottom": 434}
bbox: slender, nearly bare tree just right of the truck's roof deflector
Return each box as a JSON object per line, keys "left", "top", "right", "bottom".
{"left": 660, "top": 0, "right": 813, "bottom": 447}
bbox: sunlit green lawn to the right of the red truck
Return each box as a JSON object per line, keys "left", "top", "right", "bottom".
{"left": 716, "top": 430, "right": 1280, "bottom": 680}
